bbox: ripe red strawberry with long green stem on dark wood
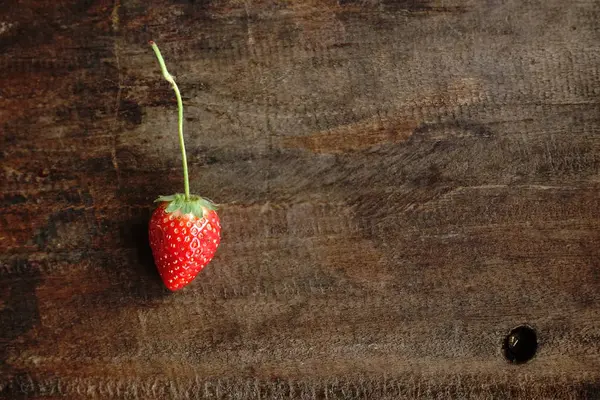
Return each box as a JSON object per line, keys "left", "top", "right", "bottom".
{"left": 148, "top": 41, "right": 221, "bottom": 291}
